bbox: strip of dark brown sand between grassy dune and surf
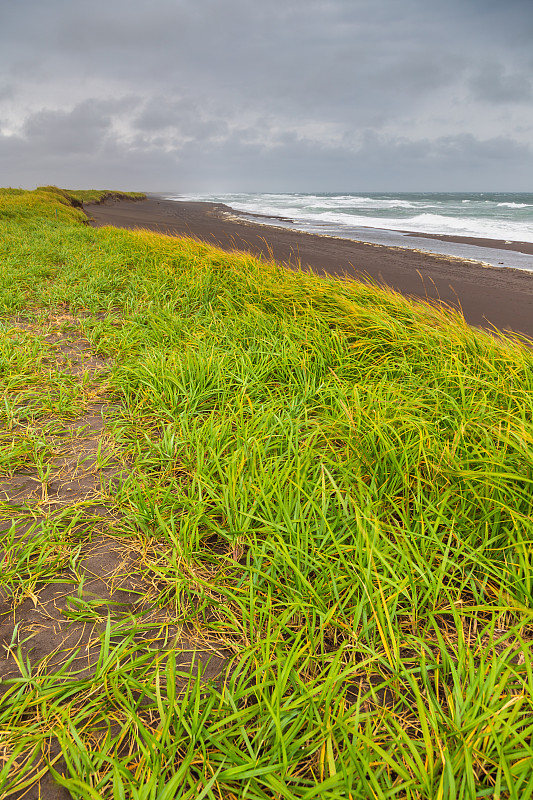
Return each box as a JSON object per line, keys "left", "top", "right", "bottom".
{"left": 87, "top": 197, "right": 533, "bottom": 338}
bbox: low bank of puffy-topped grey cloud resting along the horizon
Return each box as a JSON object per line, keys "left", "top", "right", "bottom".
{"left": 0, "top": 114, "right": 533, "bottom": 192}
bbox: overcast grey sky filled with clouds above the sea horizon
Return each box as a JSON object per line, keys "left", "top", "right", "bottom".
{"left": 0, "top": 0, "right": 533, "bottom": 193}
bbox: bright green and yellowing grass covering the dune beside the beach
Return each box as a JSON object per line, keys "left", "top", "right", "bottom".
{"left": 0, "top": 187, "right": 533, "bottom": 800}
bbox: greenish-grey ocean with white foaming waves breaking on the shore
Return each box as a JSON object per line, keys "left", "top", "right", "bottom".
{"left": 166, "top": 192, "right": 533, "bottom": 271}
